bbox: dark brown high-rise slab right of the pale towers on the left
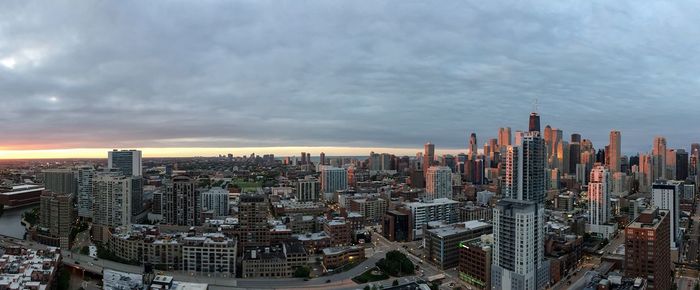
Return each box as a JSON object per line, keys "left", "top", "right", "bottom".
{"left": 163, "top": 175, "right": 202, "bottom": 226}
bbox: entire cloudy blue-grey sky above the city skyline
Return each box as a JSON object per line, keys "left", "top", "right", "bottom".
{"left": 0, "top": 0, "right": 700, "bottom": 158}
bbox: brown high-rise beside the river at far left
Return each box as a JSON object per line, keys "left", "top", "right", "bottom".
{"left": 39, "top": 191, "right": 74, "bottom": 249}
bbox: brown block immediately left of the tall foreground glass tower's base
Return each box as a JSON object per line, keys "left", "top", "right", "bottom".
{"left": 458, "top": 234, "right": 493, "bottom": 290}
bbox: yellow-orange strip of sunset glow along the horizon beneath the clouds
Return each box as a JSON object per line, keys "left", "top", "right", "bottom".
{"left": 0, "top": 146, "right": 466, "bottom": 160}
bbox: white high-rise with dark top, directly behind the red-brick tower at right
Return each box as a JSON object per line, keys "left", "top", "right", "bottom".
{"left": 651, "top": 180, "right": 683, "bottom": 249}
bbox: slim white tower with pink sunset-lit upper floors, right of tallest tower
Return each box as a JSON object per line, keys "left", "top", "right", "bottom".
{"left": 588, "top": 165, "right": 612, "bottom": 225}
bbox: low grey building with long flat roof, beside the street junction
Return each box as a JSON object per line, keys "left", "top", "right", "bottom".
{"left": 423, "top": 221, "right": 493, "bottom": 270}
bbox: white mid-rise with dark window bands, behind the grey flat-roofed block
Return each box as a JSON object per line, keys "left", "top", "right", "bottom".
{"left": 406, "top": 198, "right": 459, "bottom": 239}
